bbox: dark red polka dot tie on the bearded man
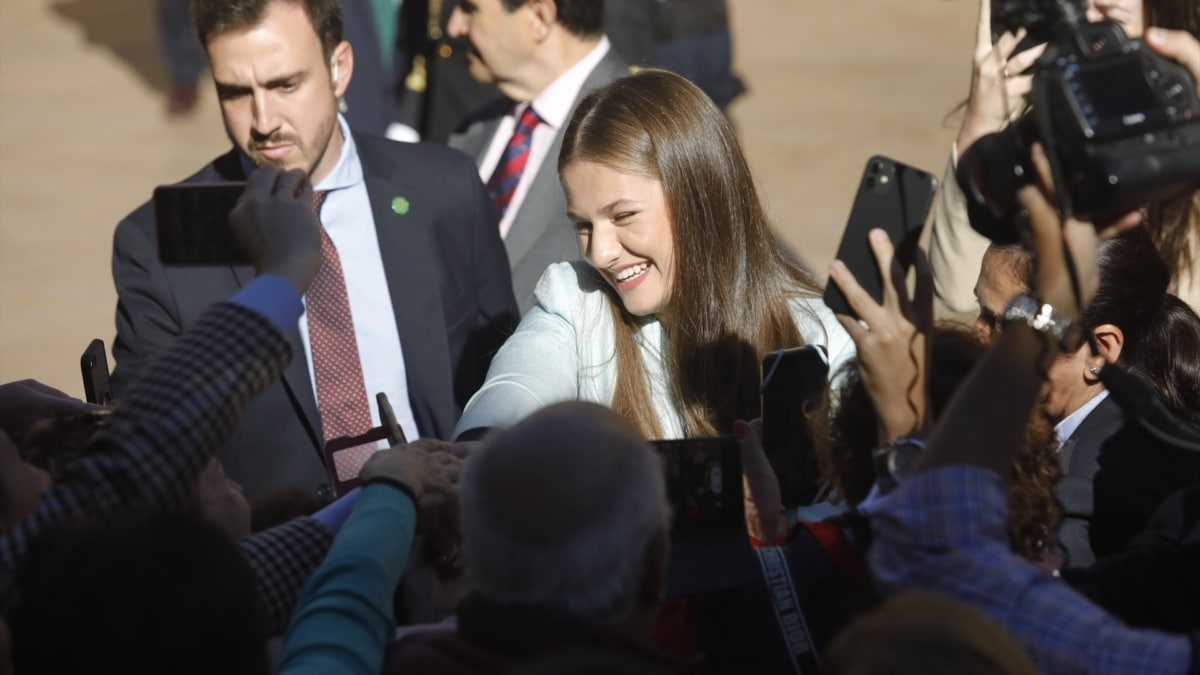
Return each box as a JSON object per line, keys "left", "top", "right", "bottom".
{"left": 305, "top": 191, "right": 376, "bottom": 482}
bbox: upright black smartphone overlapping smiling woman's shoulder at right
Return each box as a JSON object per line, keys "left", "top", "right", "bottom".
{"left": 761, "top": 345, "right": 829, "bottom": 507}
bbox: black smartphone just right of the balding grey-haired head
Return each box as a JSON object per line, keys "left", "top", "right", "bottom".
{"left": 652, "top": 435, "right": 745, "bottom": 533}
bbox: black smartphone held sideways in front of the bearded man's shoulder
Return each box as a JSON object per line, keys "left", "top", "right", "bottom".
{"left": 154, "top": 183, "right": 250, "bottom": 265}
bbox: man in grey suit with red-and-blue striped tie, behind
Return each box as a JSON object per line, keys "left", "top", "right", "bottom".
{"left": 446, "top": 0, "right": 629, "bottom": 312}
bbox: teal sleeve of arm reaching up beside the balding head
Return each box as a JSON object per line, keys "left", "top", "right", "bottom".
{"left": 278, "top": 484, "right": 416, "bottom": 675}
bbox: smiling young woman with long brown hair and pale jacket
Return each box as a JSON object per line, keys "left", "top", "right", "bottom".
{"left": 456, "top": 70, "right": 853, "bottom": 438}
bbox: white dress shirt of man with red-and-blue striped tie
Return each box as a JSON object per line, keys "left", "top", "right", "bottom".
{"left": 479, "top": 37, "right": 610, "bottom": 238}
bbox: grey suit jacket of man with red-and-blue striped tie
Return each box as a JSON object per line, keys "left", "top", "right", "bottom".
{"left": 450, "top": 49, "right": 629, "bottom": 313}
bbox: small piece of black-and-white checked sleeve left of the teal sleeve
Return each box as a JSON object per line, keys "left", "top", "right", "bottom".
{"left": 241, "top": 518, "right": 334, "bottom": 635}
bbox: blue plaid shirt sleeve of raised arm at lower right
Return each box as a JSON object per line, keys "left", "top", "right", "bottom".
{"left": 870, "top": 465, "right": 1192, "bottom": 675}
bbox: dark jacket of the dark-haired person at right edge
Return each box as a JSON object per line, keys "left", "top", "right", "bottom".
{"left": 1058, "top": 396, "right": 1200, "bottom": 567}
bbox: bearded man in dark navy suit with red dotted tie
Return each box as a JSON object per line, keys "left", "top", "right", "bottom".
{"left": 113, "top": 0, "right": 516, "bottom": 496}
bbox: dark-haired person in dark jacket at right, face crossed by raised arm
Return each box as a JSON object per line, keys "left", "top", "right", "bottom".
{"left": 977, "top": 227, "right": 1200, "bottom": 567}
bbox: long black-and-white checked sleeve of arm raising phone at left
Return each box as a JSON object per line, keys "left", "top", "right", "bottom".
{"left": 0, "top": 303, "right": 292, "bottom": 569}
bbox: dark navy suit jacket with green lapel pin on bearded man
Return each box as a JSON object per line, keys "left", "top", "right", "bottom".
{"left": 113, "top": 135, "right": 517, "bottom": 496}
